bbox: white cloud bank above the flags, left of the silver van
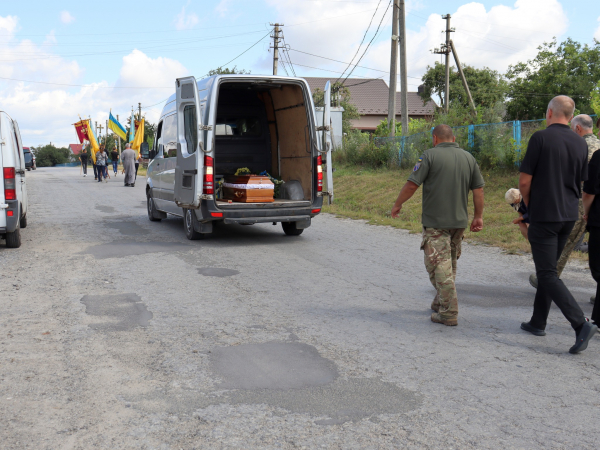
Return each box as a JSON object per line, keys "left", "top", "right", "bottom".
{"left": 0, "top": 17, "right": 189, "bottom": 146}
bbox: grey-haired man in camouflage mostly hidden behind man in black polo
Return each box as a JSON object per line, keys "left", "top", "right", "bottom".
{"left": 529, "top": 114, "right": 600, "bottom": 289}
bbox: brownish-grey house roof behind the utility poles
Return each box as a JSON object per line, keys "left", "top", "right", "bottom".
{"left": 304, "top": 77, "right": 437, "bottom": 116}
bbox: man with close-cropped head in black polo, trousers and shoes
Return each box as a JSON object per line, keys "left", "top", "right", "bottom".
{"left": 519, "top": 95, "right": 598, "bottom": 353}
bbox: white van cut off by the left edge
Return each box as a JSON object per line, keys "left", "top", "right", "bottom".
{"left": 0, "top": 111, "right": 27, "bottom": 248}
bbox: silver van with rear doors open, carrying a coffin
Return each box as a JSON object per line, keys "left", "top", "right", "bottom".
{"left": 142, "top": 75, "right": 331, "bottom": 239}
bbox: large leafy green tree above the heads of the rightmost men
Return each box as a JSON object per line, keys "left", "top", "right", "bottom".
{"left": 506, "top": 38, "right": 600, "bottom": 120}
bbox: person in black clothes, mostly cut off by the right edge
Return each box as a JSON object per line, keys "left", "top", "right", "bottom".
{"left": 583, "top": 151, "right": 600, "bottom": 326}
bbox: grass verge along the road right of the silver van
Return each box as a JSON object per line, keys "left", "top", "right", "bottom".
{"left": 323, "top": 166, "right": 556, "bottom": 254}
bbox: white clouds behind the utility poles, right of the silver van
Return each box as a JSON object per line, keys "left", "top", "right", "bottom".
{"left": 263, "top": 0, "right": 568, "bottom": 90}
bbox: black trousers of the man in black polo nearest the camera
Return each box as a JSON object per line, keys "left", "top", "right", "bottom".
{"left": 527, "top": 221, "right": 591, "bottom": 330}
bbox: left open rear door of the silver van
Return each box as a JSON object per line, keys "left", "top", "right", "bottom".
{"left": 174, "top": 77, "right": 204, "bottom": 208}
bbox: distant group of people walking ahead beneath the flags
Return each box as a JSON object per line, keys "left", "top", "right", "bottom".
{"left": 79, "top": 143, "right": 141, "bottom": 187}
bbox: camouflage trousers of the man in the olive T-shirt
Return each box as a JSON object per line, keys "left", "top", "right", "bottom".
{"left": 421, "top": 228, "right": 465, "bottom": 319}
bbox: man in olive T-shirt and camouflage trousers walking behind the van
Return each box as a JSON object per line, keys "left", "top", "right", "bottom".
{"left": 392, "top": 125, "right": 484, "bottom": 326}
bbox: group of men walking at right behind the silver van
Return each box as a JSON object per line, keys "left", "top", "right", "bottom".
{"left": 391, "top": 95, "right": 600, "bottom": 353}
